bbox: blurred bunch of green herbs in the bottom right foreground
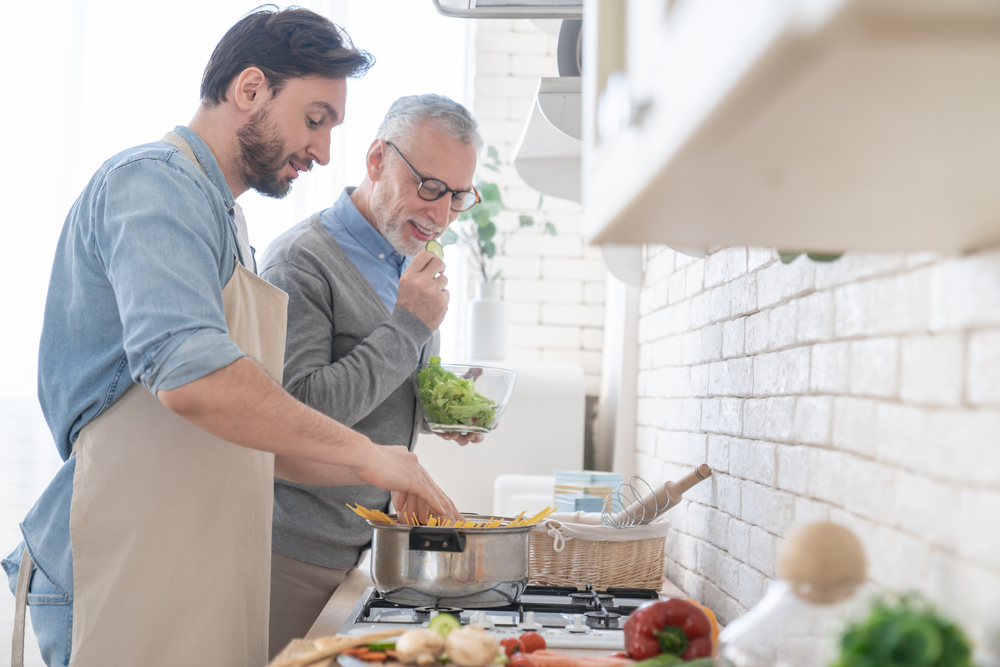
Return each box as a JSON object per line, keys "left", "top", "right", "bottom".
{"left": 832, "top": 593, "right": 973, "bottom": 667}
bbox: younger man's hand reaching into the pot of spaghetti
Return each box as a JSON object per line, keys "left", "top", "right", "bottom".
{"left": 353, "top": 446, "right": 461, "bottom": 523}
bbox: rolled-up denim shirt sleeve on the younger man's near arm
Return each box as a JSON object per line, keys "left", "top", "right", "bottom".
{"left": 92, "top": 154, "right": 243, "bottom": 393}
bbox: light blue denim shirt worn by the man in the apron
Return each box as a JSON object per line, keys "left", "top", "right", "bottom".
{"left": 3, "top": 126, "right": 253, "bottom": 599}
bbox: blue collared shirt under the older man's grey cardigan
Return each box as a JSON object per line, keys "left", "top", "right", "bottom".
{"left": 319, "top": 188, "right": 412, "bottom": 314}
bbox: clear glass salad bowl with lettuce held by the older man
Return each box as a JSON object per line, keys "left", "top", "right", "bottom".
{"left": 413, "top": 357, "right": 517, "bottom": 433}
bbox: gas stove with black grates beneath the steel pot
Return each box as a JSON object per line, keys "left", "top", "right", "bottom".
{"left": 338, "top": 584, "right": 659, "bottom": 650}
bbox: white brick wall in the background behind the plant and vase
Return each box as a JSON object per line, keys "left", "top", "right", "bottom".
{"left": 473, "top": 20, "right": 604, "bottom": 396}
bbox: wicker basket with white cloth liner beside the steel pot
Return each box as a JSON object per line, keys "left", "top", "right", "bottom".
{"left": 529, "top": 512, "right": 668, "bottom": 590}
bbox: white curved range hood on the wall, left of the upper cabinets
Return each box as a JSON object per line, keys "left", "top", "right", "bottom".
{"left": 513, "top": 76, "right": 583, "bottom": 202}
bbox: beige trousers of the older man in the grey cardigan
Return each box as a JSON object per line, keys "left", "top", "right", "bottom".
{"left": 267, "top": 552, "right": 350, "bottom": 660}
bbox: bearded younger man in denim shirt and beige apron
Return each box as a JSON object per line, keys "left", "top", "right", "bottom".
{"left": 3, "top": 9, "right": 457, "bottom": 667}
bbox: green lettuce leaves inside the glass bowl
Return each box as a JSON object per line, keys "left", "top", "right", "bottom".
{"left": 417, "top": 357, "right": 497, "bottom": 427}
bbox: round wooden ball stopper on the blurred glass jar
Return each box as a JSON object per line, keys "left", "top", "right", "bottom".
{"left": 778, "top": 522, "right": 865, "bottom": 604}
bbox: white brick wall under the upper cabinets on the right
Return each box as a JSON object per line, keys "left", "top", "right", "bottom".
{"left": 638, "top": 246, "right": 1000, "bottom": 650}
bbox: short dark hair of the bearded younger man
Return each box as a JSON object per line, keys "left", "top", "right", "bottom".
{"left": 201, "top": 5, "right": 375, "bottom": 106}
